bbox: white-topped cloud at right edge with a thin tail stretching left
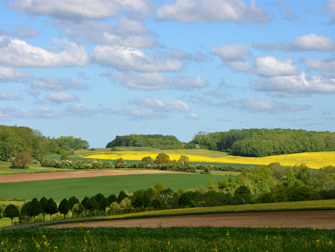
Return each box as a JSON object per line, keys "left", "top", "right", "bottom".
{"left": 252, "top": 33, "right": 335, "bottom": 52}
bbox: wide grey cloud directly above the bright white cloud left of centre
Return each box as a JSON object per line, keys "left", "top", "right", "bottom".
{"left": 54, "top": 18, "right": 159, "bottom": 48}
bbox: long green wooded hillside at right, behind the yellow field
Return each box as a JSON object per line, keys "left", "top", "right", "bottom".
{"left": 185, "top": 129, "right": 335, "bottom": 157}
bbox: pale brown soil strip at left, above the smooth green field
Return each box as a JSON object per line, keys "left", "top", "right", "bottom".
{"left": 0, "top": 170, "right": 180, "bottom": 183}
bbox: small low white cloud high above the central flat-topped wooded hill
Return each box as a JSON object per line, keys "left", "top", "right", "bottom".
{"left": 131, "top": 97, "right": 191, "bottom": 112}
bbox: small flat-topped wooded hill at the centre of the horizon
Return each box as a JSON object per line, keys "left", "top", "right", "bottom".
{"left": 106, "top": 134, "right": 183, "bottom": 149}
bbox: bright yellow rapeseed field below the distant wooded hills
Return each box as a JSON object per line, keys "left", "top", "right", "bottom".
{"left": 81, "top": 150, "right": 335, "bottom": 169}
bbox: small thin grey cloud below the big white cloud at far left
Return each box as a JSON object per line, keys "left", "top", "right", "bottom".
{"left": 31, "top": 77, "right": 88, "bottom": 91}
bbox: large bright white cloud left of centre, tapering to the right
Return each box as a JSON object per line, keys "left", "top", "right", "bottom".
{"left": 91, "top": 46, "right": 183, "bottom": 72}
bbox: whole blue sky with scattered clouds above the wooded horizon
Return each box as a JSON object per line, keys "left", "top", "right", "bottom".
{"left": 0, "top": 0, "right": 335, "bottom": 148}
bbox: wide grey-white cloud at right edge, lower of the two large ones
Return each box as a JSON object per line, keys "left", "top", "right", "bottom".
{"left": 252, "top": 72, "right": 335, "bottom": 97}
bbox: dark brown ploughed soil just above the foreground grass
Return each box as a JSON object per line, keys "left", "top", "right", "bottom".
{"left": 48, "top": 210, "right": 335, "bottom": 229}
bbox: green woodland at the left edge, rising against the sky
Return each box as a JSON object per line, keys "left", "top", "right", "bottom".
{"left": 0, "top": 125, "right": 89, "bottom": 162}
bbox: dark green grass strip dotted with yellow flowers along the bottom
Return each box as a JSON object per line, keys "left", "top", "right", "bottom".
{"left": 0, "top": 227, "right": 335, "bottom": 252}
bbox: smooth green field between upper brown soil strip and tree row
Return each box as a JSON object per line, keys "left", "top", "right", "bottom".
{"left": 0, "top": 173, "right": 228, "bottom": 202}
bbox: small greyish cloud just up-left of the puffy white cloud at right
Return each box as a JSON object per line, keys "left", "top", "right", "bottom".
{"left": 210, "top": 44, "right": 251, "bottom": 61}
